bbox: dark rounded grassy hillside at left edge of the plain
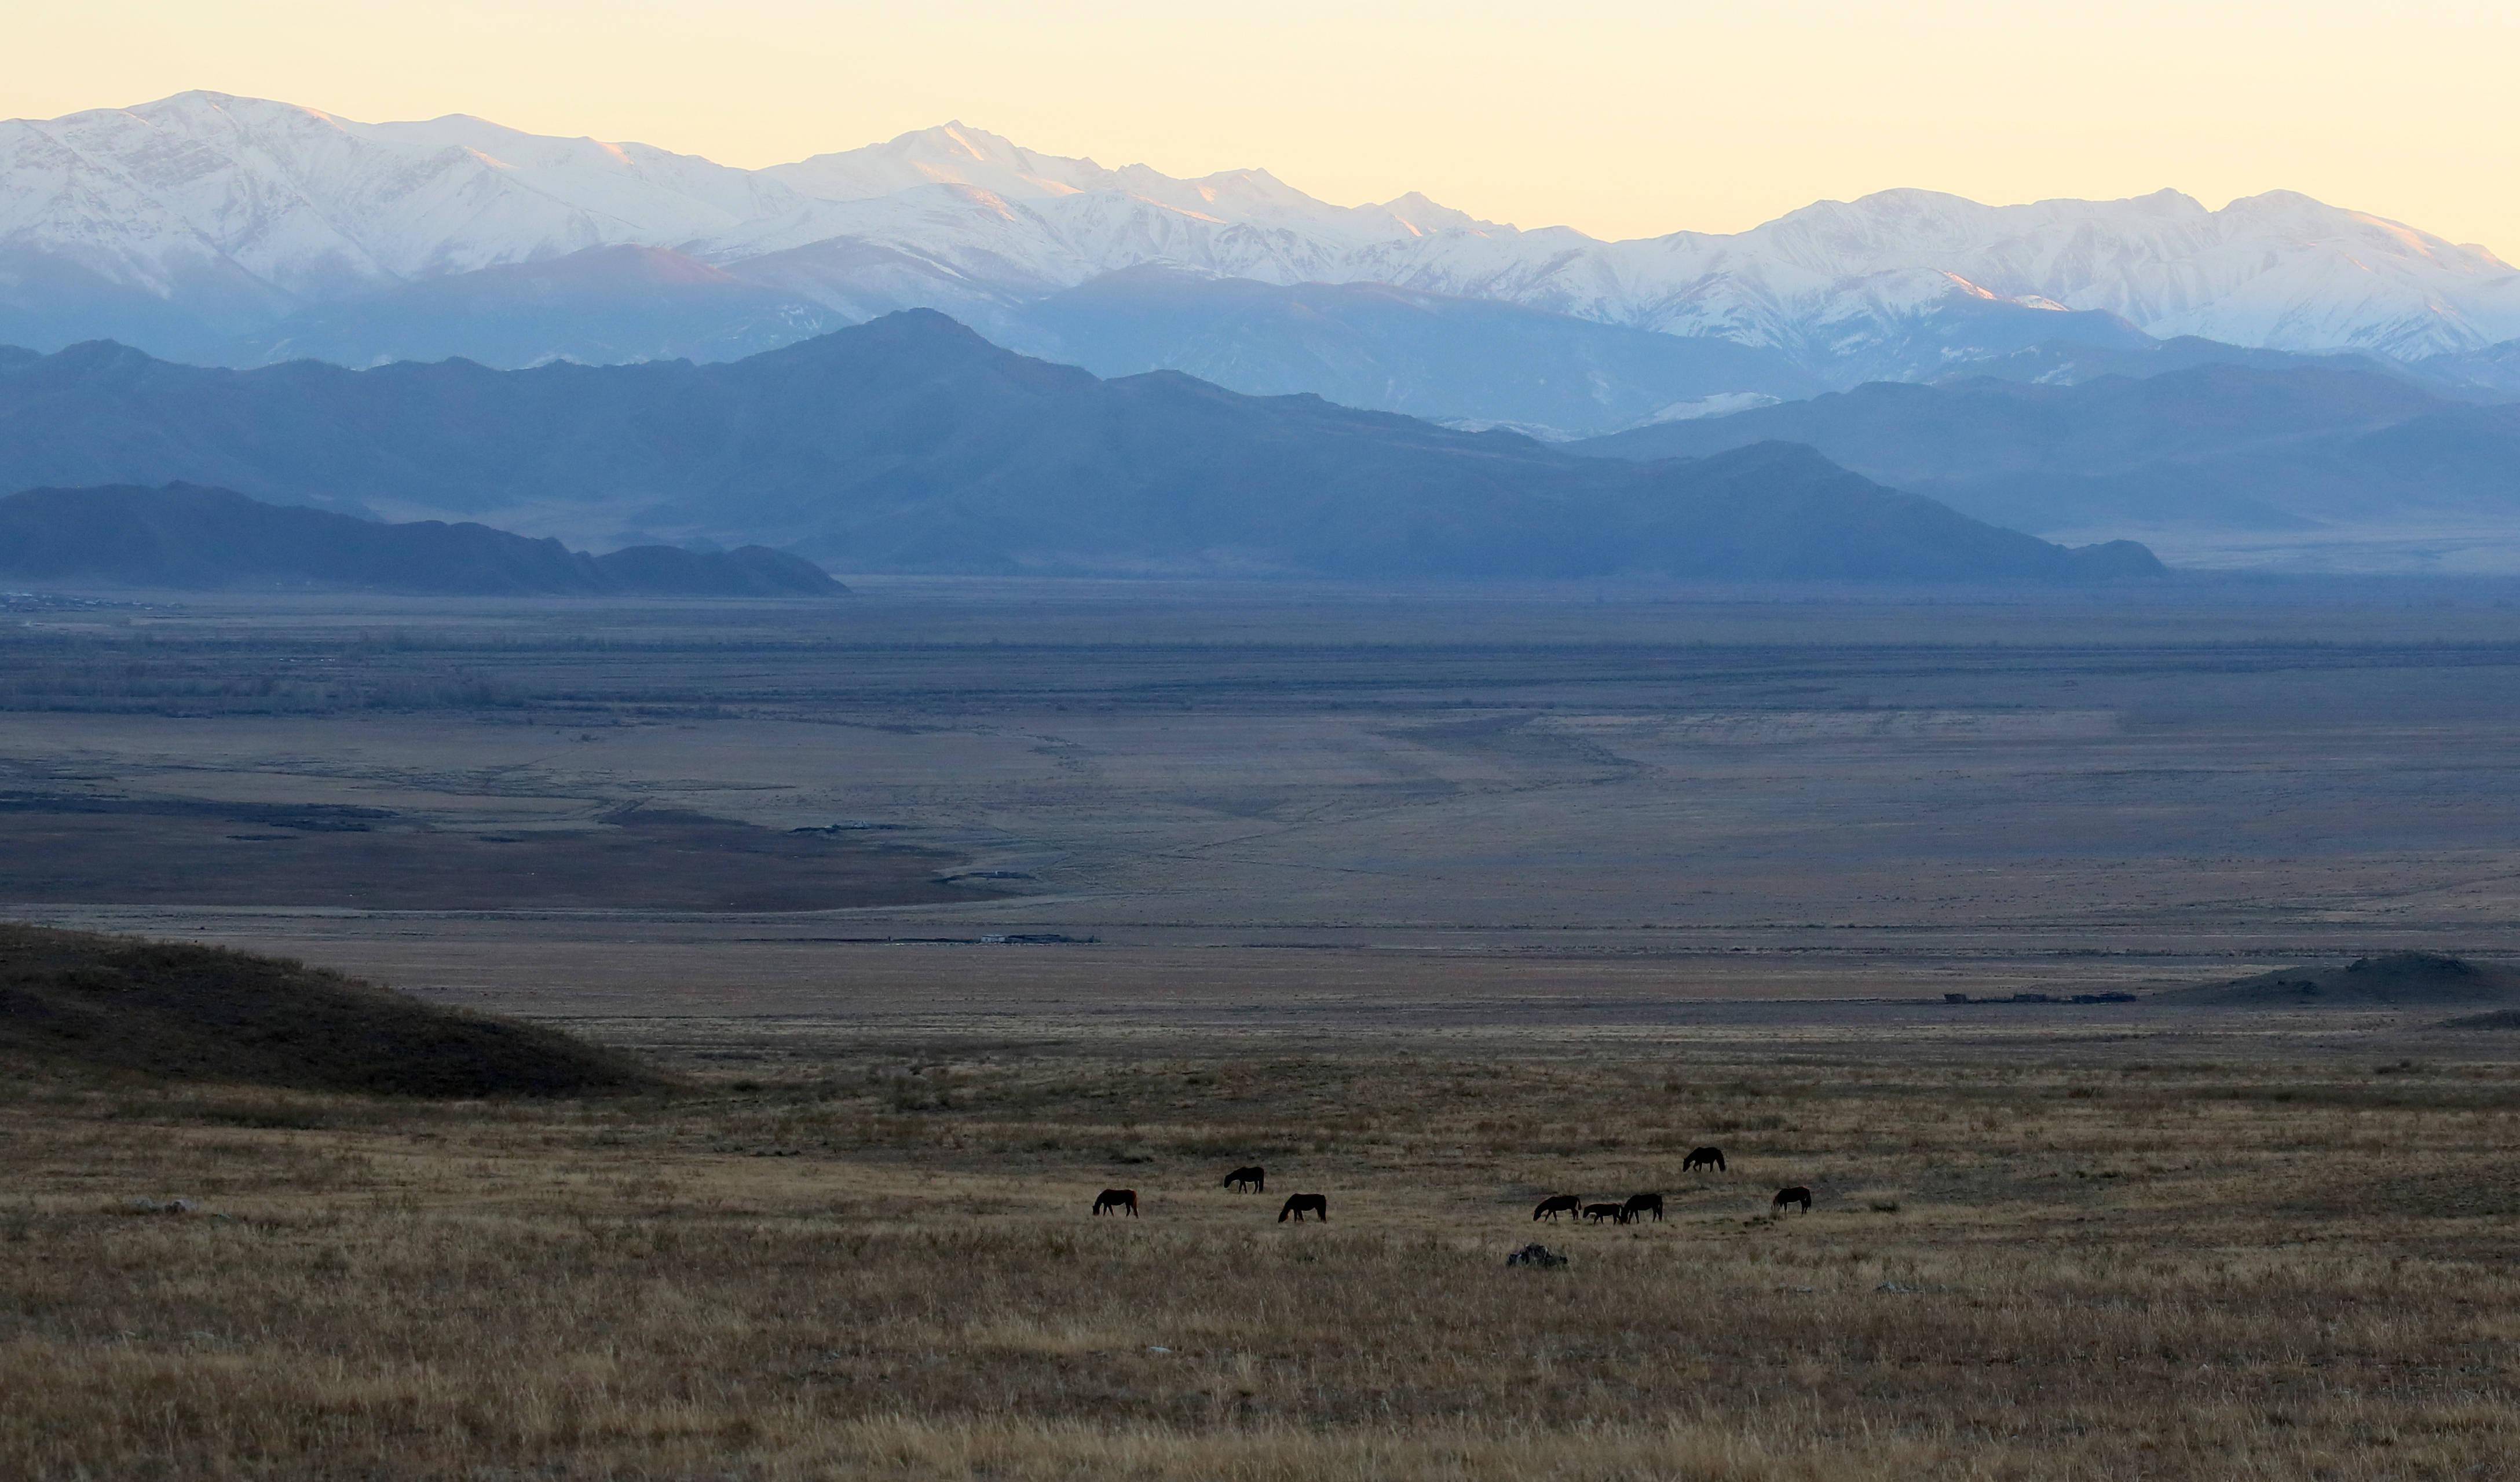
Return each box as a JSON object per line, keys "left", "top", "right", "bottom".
{"left": 0, "top": 925, "right": 665, "bottom": 1096}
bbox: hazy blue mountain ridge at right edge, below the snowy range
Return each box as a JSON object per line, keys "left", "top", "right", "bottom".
{"left": 1572, "top": 363, "right": 2520, "bottom": 530}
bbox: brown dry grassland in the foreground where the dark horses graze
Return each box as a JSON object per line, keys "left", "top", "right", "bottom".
{"left": 0, "top": 1036, "right": 2520, "bottom": 1480}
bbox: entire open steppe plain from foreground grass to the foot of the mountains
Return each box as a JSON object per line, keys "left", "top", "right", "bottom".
{"left": 0, "top": 580, "right": 2520, "bottom": 1477}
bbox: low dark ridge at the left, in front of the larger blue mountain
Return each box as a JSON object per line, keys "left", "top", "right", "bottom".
{"left": 0, "top": 484, "right": 842, "bottom": 597}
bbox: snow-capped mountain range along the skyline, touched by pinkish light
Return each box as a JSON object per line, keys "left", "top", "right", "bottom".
{"left": 0, "top": 93, "right": 2520, "bottom": 396}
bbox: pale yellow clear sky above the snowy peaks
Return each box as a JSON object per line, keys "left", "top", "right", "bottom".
{"left": 19, "top": 0, "right": 2520, "bottom": 257}
